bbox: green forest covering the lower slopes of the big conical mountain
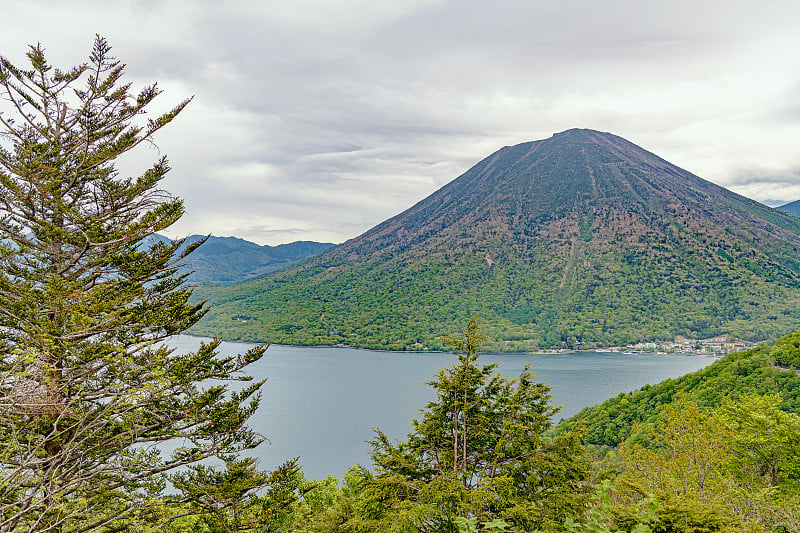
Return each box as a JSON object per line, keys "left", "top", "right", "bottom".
{"left": 190, "top": 210, "right": 800, "bottom": 351}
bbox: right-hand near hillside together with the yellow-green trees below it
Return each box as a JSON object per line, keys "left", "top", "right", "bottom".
{"left": 559, "top": 344, "right": 800, "bottom": 532}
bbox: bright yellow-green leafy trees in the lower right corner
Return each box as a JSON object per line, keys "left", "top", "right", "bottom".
{"left": 592, "top": 395, "right": 800, "bottom": 532}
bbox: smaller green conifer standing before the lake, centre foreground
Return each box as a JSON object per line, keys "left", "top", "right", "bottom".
{"left": 362, "top": 319, "right": 589, "bottom": 531}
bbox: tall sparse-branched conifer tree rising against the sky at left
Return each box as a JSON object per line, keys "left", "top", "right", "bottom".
{"left": 0, "top": 36, "right": 282, "bottom": 532}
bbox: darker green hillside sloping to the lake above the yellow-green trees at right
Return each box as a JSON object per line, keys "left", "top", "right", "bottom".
{"left": 558, "top": 331, "right": 800, "bottom": 446}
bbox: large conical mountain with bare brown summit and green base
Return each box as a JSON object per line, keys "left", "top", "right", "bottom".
{"left": 186, "top": 129, "right": 800, "bottom": 350}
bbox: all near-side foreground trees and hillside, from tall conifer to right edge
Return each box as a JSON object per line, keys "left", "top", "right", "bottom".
{"left": 0, "top": 36, "right": 800, "bottom": 533}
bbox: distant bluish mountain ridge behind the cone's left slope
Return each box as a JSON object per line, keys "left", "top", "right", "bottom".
{"left": 145, "top": 235, "right": 334, "bottom": 284}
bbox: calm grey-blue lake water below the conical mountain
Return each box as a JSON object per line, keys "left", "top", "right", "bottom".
{"left": 162, "top": 336, "right": 713, "bottom": 478}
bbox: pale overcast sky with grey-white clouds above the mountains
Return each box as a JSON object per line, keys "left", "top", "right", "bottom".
{"left": 0, "top": 0, "right": 800, "bottom": 245}
